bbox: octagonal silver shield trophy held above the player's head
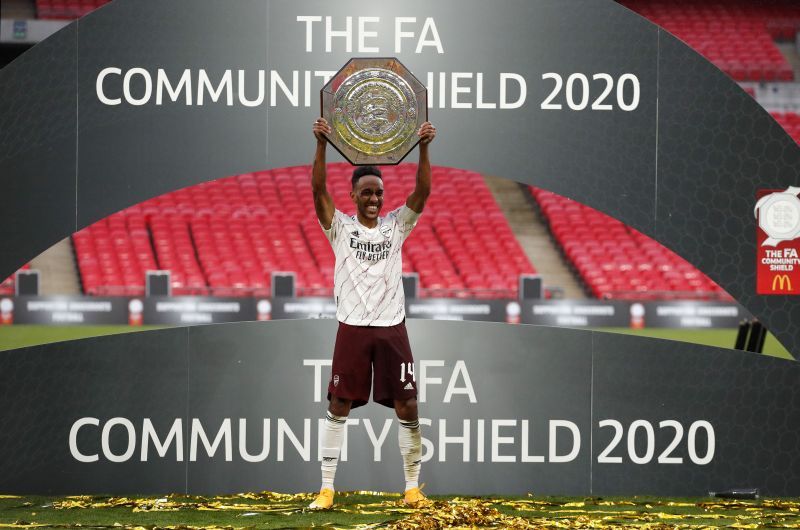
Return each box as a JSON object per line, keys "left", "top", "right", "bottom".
{"left": 320, "top": 57, "right": 428, "bottom": 166}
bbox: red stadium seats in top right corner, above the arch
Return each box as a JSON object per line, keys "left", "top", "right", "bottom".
{"left": 621, "top": 0, "right": 800, "bottom": 81}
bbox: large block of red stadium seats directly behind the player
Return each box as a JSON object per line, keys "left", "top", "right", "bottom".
{"left": 73, "top": 163, "right": 535, "bottom": 298}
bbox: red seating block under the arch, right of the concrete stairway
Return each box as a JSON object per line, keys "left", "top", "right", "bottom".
{"left": 530, "top": 187, "right": 730, "bottom": 300}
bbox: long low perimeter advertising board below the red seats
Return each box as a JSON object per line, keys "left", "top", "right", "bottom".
{"left": 0, "top": 296, "right": 752, "bottom": 328}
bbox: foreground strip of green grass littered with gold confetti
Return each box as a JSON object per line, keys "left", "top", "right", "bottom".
{"left": 0, "top": 491, "right": 800, "bottom": 530}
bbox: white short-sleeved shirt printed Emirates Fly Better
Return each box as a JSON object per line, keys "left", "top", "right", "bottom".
{"left": 323, "top": 205, "right": 420, "bottom": 327}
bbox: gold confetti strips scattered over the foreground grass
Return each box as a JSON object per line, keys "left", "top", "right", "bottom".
{"left": 32, "top": 491, "right": 800, "bottom": 530}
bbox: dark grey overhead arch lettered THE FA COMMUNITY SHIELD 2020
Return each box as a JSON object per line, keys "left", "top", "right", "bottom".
{"left": 0, "top": 0, "right": 800, "bottom": 356}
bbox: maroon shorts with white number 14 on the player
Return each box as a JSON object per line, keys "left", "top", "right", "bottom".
{"left": 328, "top": 321, "right": 417, "bottom": 408}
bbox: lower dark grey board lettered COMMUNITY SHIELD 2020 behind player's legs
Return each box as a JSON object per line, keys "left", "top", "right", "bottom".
{"left": 0, "top": 320, "right": 800, "bottom": 496}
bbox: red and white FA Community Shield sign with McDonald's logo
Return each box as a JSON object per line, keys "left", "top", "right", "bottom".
{"left": 754, "top": 186, "right": 800, "bottom": 294}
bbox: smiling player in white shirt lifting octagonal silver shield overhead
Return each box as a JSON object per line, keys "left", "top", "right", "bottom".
{"left": 309, "top": 59, "right": 436, "bottom": 509}
